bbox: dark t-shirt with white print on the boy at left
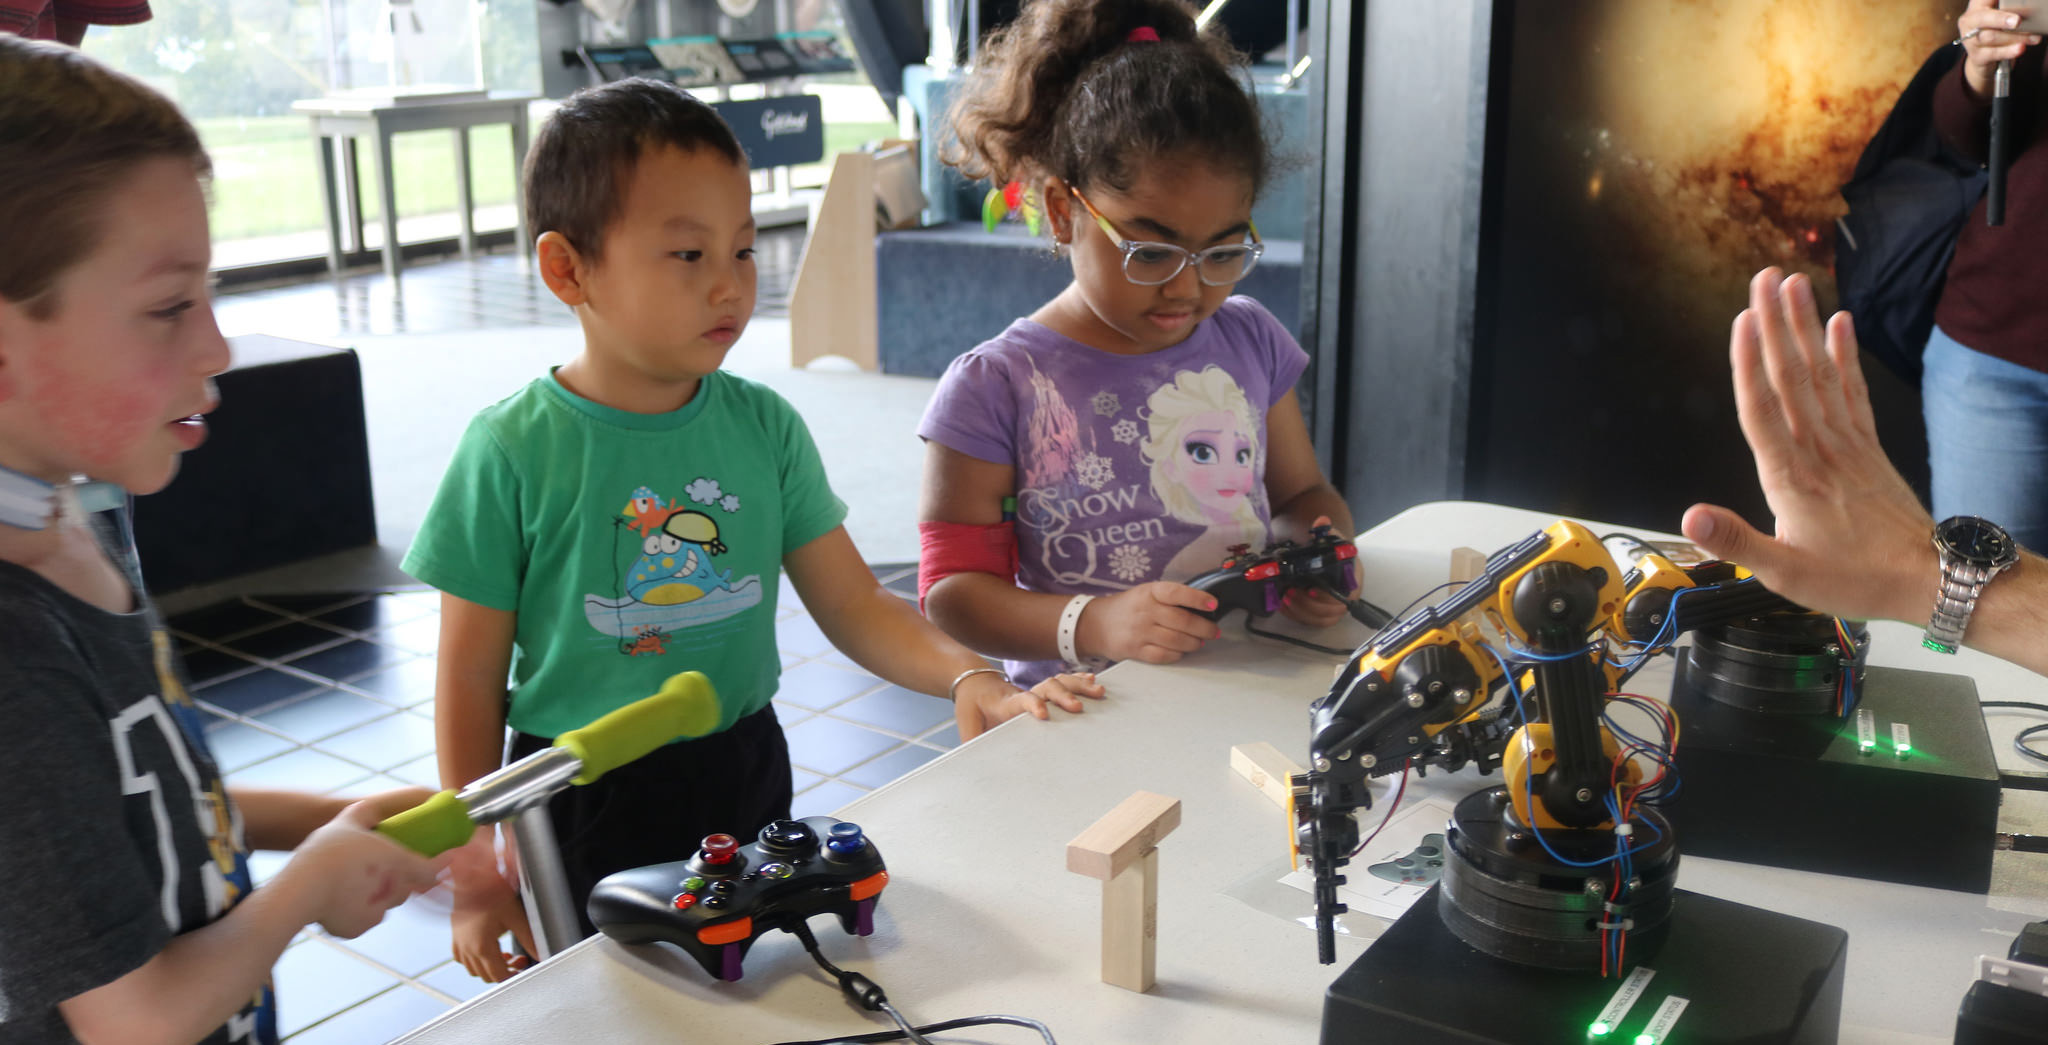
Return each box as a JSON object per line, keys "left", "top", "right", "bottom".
{"left": 0, "top": 516, "right": 276, "bottom": 1045}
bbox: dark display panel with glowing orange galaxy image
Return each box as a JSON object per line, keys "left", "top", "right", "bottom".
{"left": 1466, "top": 0, "right": 1962, "bottom": 529}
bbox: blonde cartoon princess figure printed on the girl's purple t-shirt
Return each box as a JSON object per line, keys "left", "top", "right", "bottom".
{"left": 1139, "top": 365, "right": 1266, "bottom": 580}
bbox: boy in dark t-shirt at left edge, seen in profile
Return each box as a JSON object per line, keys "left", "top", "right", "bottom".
{"left": 0, "top": 35, "right": 434, "bottom": 1045}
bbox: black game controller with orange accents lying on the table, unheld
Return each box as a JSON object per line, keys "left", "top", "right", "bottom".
{"left": 590, "top": 816, "right": 889, "bottom": 979}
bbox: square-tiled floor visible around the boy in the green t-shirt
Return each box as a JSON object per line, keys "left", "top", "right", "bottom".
{"left": 170, "top": 566, "right": 942, "bottom": 1045}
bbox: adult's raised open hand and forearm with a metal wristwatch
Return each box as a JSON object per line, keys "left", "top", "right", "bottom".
{"left": 1681, "top": 268, "right": 2048, "bottom": 674}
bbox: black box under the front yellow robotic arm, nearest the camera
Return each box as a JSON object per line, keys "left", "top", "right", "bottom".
{"left": 1321, "top": 885, "right": 1849, "bottom": 1045}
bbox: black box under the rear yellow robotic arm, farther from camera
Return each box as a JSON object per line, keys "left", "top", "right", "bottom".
{"left": 1661, "top": 656, "right": 1999, "bottom": 893}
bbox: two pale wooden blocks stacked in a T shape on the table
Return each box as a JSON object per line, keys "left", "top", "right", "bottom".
{"left": 1067, "top": 791, "right": 1180, "bottom": 994}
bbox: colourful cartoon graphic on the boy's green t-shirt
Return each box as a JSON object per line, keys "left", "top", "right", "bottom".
{"left": 584, "top": 477, "right": 762, "bottom": 656}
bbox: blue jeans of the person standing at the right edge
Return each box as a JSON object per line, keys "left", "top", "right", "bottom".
{"left": 1921, "top": 326, "right": 2048, "bottom": 551}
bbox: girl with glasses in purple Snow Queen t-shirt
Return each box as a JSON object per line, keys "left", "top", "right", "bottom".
{"left": 918, "top": 0, "right": 1352, "bottom": 682}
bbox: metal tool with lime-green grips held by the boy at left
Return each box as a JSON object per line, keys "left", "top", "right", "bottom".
{"left": 377, "top": 672, "right": 719, "bottom": 959}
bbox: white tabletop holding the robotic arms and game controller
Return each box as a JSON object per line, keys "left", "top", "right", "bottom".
{"left": 401, "top": 502, "right": 2048, "bottom": 1045}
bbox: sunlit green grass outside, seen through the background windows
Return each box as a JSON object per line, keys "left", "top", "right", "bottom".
{"left": 197, "top": 117, "right": 895, "bottom": 240}
